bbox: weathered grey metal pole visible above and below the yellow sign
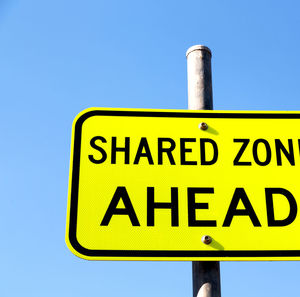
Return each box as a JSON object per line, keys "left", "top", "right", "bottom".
{"left": 186, "top": 45, "right": 221, "bottom": 297}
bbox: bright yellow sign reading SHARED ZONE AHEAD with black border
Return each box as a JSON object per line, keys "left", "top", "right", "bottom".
{"left": 66, "top": 108, "right": 300, "bottom": 261}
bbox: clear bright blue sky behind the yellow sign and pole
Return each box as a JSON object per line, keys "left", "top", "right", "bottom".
{"left": 0, "top": 0, "right": 300, "bottom": 297}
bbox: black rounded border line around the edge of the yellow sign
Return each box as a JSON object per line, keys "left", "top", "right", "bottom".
{"left": 68, "top": 109, "right": 300, "bottom": 260}
